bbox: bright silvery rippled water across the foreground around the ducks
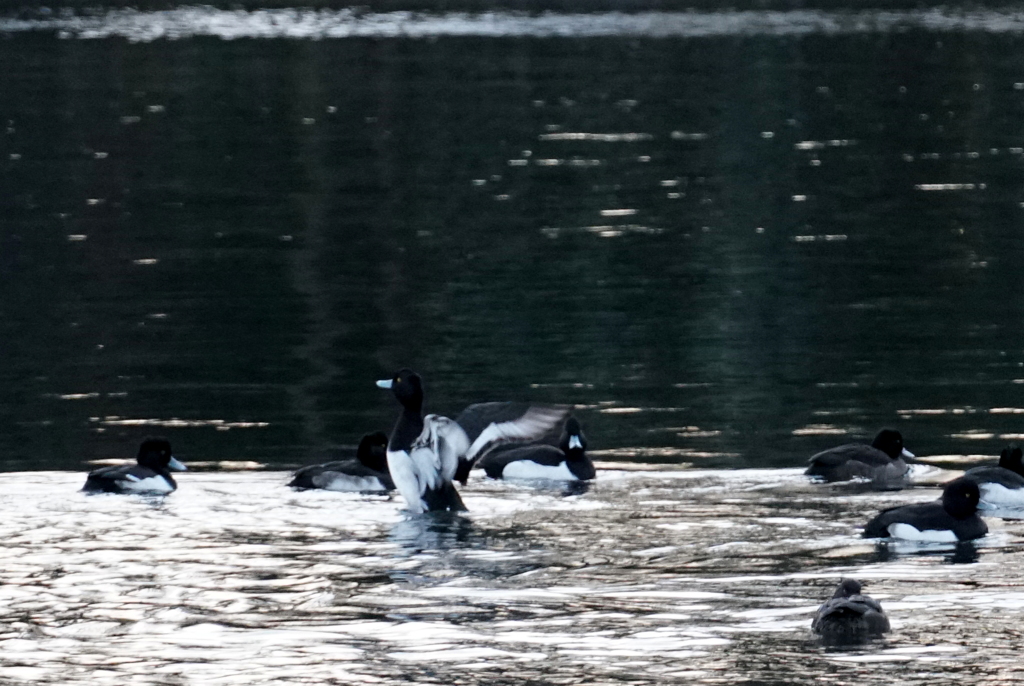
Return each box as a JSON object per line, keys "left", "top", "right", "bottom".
{"left": 0, "top": 470, "right": 1024, "bottom": 684}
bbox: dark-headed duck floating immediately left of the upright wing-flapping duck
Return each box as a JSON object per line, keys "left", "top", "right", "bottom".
{"left": 288, "top": 431, "right": 394, "bottom": 492}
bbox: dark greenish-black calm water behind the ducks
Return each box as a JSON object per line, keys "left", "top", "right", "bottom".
{"left": 6, "top": 5, "right": 1024, "bottom": 470}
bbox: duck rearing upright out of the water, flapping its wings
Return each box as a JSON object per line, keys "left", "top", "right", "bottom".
{"left": 377, "top": 368, "right": 564, "bottom": 514}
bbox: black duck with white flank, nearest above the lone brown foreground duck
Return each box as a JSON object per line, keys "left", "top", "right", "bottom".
{"left": 864, "top": 476, "right": 988, "bottom": 543}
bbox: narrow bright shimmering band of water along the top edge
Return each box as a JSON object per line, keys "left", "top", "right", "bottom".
{"left": 8, "top": 7, "right": 1024, "bottom": 42}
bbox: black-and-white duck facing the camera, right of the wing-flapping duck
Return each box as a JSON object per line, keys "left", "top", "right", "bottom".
{"left": 477, "top": 417, "right": 597, "bottom": 481}
